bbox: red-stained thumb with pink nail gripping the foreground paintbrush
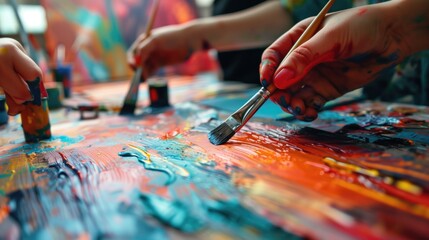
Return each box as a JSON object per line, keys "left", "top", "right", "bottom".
{"left": 274, "top": 32, "right": 340, "bottom": 89}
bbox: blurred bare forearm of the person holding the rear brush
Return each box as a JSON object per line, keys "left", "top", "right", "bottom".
{"left": 185, "top": 0, "right": 292, "bottom": 51}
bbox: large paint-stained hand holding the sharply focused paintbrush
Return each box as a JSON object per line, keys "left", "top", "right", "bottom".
{"left": 260, "top": 1, "right": 409, "bottom": 121}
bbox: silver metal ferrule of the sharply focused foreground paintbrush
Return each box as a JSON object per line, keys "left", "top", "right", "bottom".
{"left": 225, "top": 88, "right": 271, "bottom": 132}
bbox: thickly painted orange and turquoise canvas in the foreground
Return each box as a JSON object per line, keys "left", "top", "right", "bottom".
{"left": 0, "top": 97, "right": 429, "bottom": 239}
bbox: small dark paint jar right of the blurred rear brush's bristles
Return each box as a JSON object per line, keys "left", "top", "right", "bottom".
{"left": 148, "top": 79, "right": 170, "bottom": 108}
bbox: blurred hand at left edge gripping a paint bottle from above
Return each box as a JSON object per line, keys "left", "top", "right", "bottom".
{"left": 0, "top": 38, "right": 42, "bottom": 115}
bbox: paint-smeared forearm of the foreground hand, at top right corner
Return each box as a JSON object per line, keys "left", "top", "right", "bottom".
{"left": 391, "top": 0, "right": 429, "bottom": 55}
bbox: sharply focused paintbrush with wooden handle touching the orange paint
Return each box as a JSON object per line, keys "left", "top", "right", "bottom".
{"left": 208, "top": 0, "right": 335, "bottom": 145}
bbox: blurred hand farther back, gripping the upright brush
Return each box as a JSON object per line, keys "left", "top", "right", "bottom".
{"left": 127, "top": 24, "right": 198, "bottom": 75}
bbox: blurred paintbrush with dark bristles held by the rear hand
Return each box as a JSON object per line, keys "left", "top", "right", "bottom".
{"left": 119, "top": 0, "right": 159, "bottom": 115}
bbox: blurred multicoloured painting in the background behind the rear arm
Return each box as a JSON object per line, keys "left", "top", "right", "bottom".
{"left": 41, "top": 0, "right": 217, "bottom": 85}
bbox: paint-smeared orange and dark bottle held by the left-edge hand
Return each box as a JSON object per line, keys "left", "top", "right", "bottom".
{"left": 21, "top": 78, "right": 51, "bottom": 143}
